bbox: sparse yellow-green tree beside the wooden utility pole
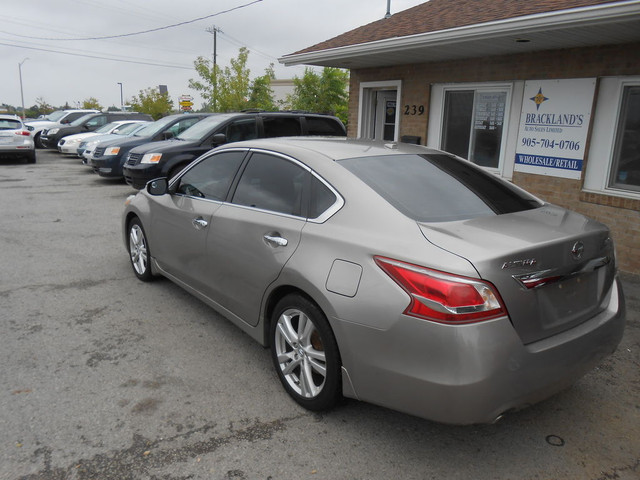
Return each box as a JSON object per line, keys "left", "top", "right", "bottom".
{"left": 189, "top": 47, "right": 275, "bottom": 112}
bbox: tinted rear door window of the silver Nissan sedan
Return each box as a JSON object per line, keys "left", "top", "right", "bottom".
{"left": 232, "top": 153, "right": 310, "bottom": 216}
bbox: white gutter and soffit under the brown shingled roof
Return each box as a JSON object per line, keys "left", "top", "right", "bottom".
{"left": 278, "top": 0, "right": 640, "bottom": 69}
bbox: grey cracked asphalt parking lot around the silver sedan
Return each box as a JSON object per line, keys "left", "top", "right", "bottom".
{"left": 0, "top": 150, "right": 640, "bottom": 480}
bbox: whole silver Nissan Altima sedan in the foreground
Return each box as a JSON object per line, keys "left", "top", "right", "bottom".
{"left": 123, "top": 138, "right": 625, "bottom": 424}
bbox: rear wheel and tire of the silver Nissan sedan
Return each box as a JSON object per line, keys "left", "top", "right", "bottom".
{"left": 269, "top": 294, "right": 342, "bottom": 411}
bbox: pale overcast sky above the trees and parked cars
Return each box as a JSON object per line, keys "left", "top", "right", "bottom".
{"left": 0, "top": 0, "right": 426, "bottom": 108}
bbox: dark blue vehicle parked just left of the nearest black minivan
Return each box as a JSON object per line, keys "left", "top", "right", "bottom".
{"left": 87, "top": 113, "right": 211, "bottom": 178}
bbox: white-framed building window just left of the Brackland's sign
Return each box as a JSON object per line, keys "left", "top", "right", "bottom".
{"left": 441, "top": 89, "right": 508, "bottom": 169}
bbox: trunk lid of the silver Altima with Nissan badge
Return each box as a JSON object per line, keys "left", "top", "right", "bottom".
{"left": 420, "top": 205, "right": 615, "bottom": 344}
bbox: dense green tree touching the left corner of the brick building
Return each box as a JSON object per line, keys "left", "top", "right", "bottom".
{"left": 288, "top": 67, "right": 349, "bottom": 123}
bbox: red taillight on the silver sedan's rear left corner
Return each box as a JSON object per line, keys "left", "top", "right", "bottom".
{"left": 374, "top": 256, "right": 507, "bottom": 324}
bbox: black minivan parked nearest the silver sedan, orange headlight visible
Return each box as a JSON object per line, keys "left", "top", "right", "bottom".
{"left": 123, "top": 112, "right": 347, "bottom": 190}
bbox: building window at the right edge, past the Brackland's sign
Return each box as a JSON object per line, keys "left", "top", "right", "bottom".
{"left": 609, "top": 86, "right": 640, "bottom": 192}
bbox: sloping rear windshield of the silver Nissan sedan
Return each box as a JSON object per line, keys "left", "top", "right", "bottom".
{"left": 339, "top": 154, "right": 541, "bottom": 222}
